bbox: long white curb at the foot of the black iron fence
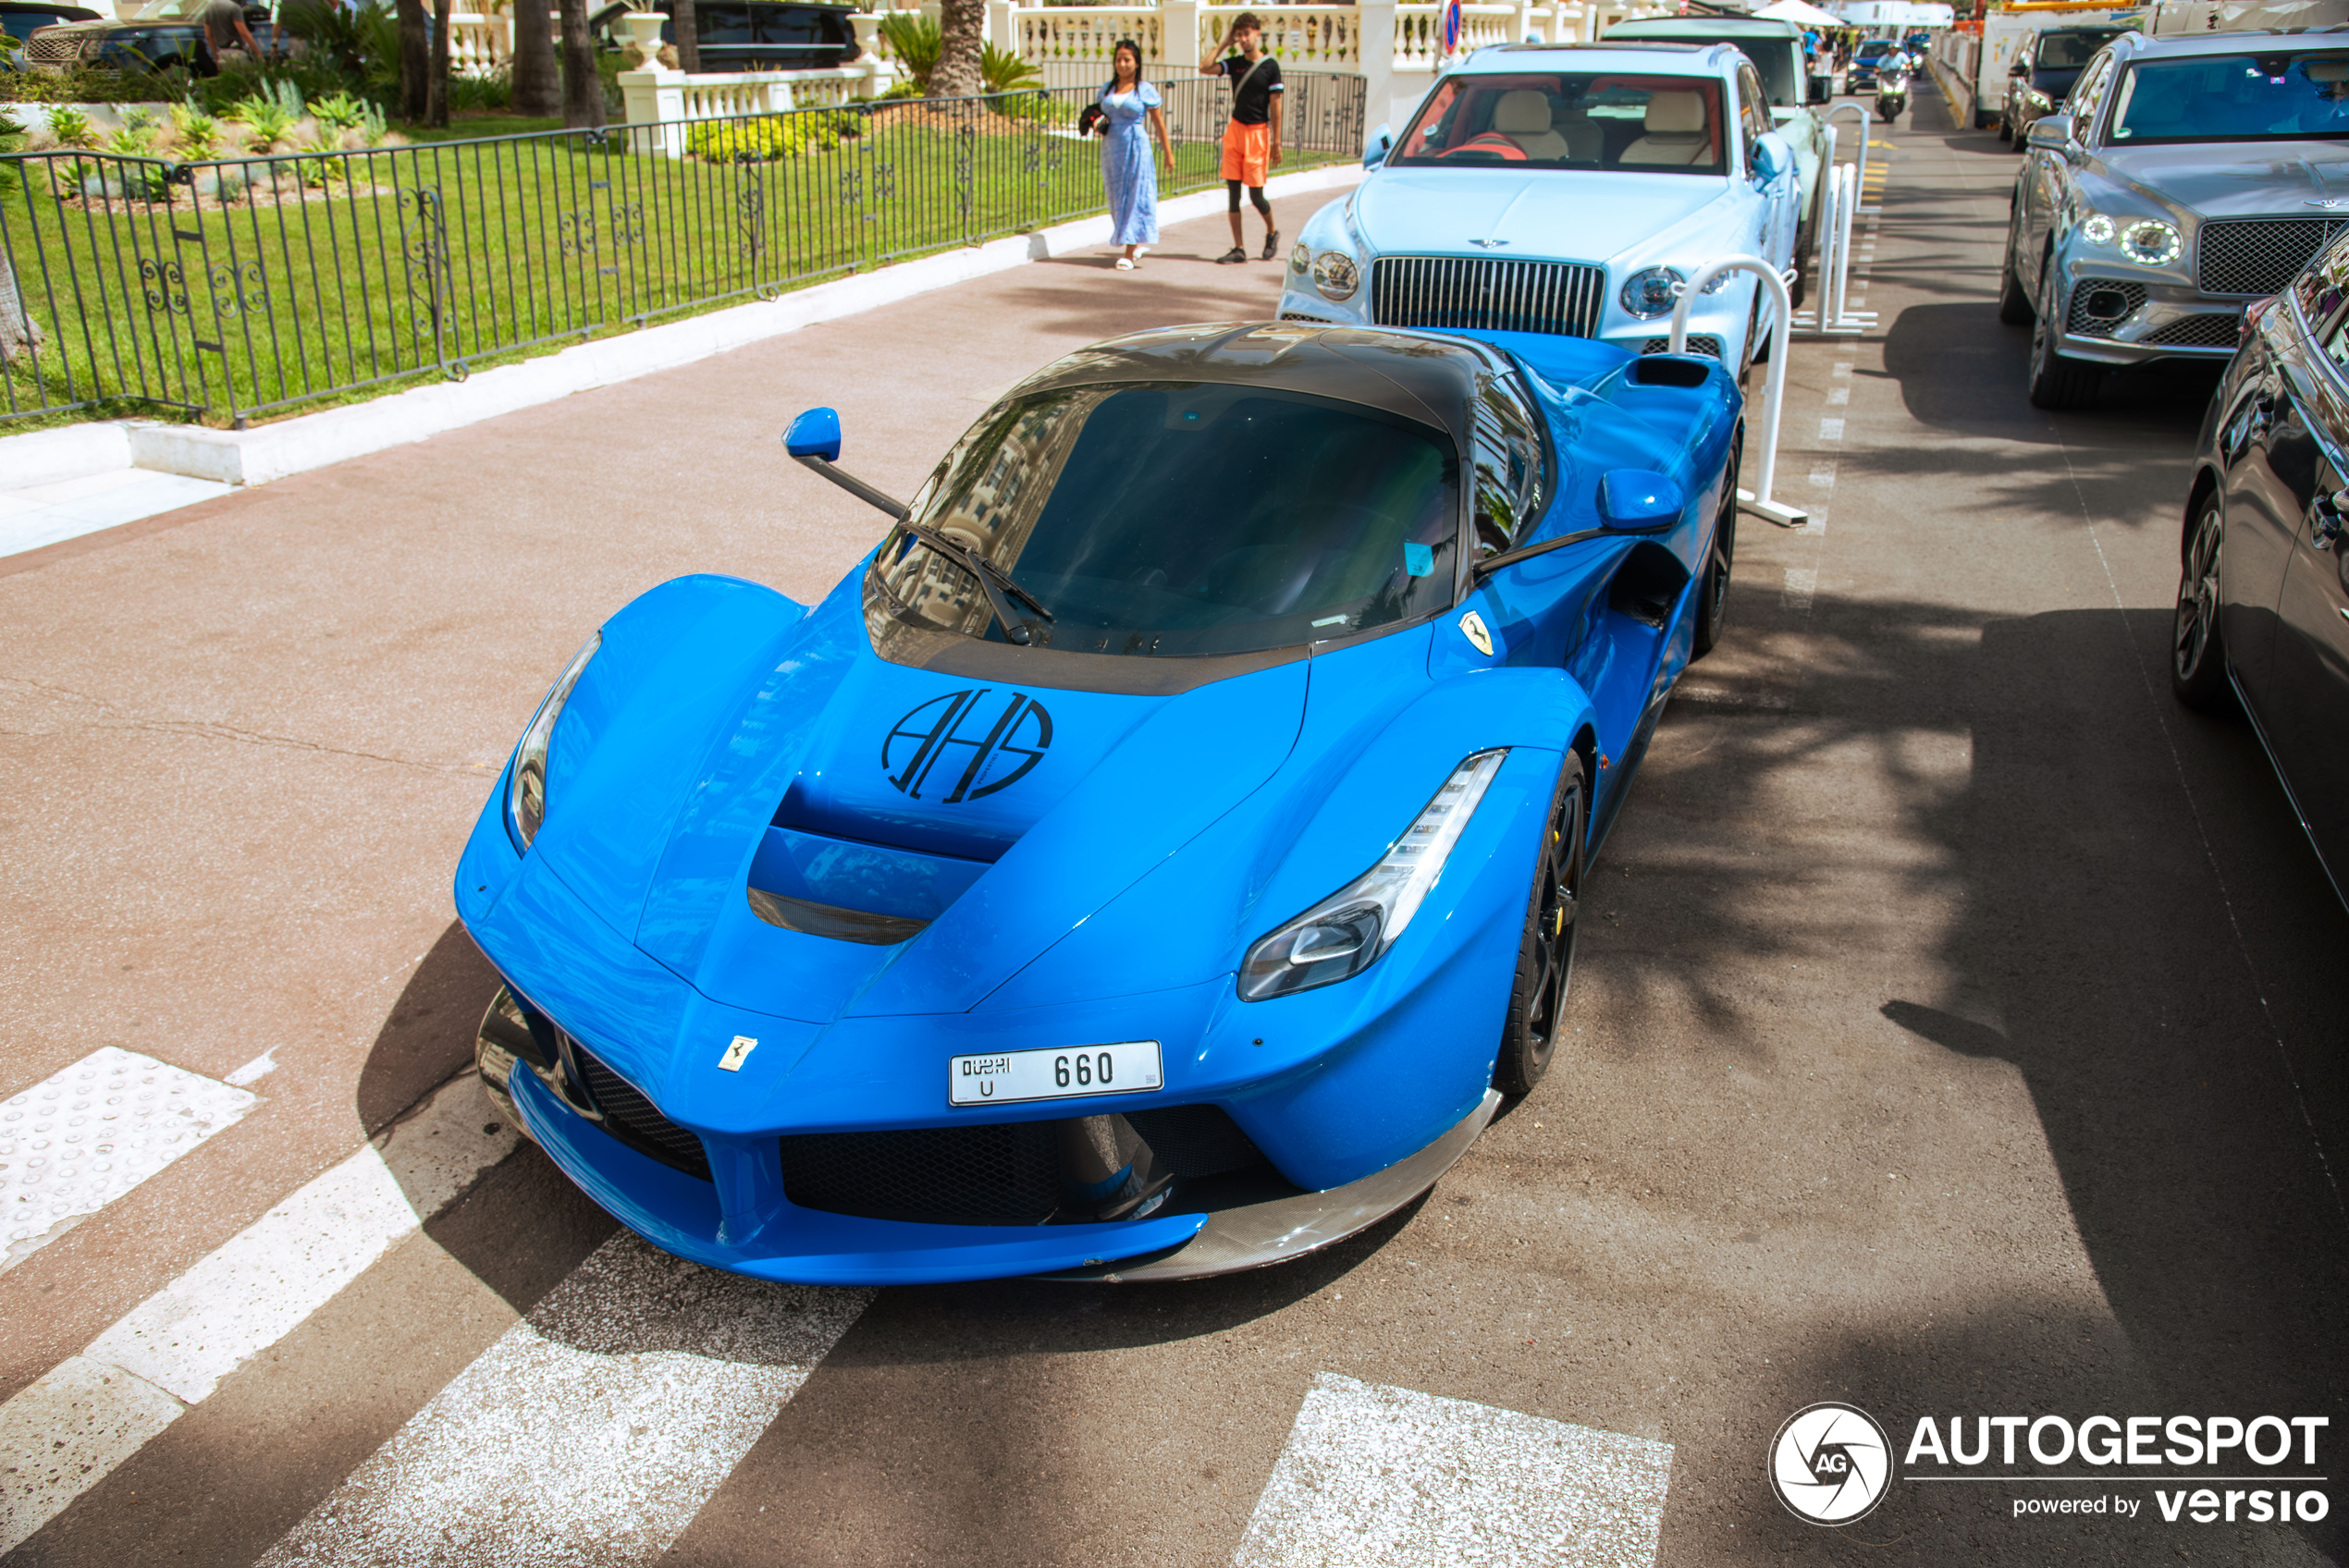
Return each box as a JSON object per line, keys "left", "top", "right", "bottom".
{"left": 0, "top": 165, "right": 1362, "bottom": 488}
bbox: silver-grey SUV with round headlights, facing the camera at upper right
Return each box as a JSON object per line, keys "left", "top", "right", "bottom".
{"left": 1999, "top": 28, "right": 2349, "bottom": 409}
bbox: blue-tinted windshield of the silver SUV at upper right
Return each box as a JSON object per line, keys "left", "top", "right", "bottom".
{"left": 2109, "top": 54, "right": 2349, "bottom": 143}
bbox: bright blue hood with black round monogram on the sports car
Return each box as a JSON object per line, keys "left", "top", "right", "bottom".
{"left": 534, "top": 575, "right": 1306, "bottom": 1023}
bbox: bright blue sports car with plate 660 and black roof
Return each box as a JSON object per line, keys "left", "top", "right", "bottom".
{"left": 456, "top": 324, "right": 1740, "bottom": 1284}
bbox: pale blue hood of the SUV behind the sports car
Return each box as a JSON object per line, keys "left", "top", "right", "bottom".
{"left": 1353, "top": 166, "right": 1728, "bottom": 261}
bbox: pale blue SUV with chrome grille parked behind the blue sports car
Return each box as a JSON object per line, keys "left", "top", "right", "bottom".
{"left": 1280, "top": 43, "right": 1802, "bottom": 378}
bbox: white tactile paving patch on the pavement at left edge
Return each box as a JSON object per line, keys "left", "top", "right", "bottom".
{"left": 0, "top": 1045, "right": 258, "bottom": 1272}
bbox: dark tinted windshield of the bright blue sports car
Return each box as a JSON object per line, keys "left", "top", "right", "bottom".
{"left": 869, "top": 383, "right": 1458, "bottom": 655}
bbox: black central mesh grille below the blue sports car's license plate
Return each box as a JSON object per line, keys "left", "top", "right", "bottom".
{"left": 780, "top": 1106, "right": 1264, "bottom": 1225}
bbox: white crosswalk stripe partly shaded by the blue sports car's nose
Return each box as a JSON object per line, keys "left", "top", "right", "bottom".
{"left": 258, "top": 1230, "right": 874, "bottom": 1568}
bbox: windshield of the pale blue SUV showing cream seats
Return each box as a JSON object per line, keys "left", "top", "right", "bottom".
{"left": 1388, "top": 70, "right": 1724, "bottom": 174}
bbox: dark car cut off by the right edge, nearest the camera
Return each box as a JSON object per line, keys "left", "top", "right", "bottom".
{"left": 2171, "top": 237, "right": 2349, "bottom": 901}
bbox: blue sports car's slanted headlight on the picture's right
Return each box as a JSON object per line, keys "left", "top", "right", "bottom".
{"left": 1240, "top": 749, "right": 1508, "bottom": 1002}
